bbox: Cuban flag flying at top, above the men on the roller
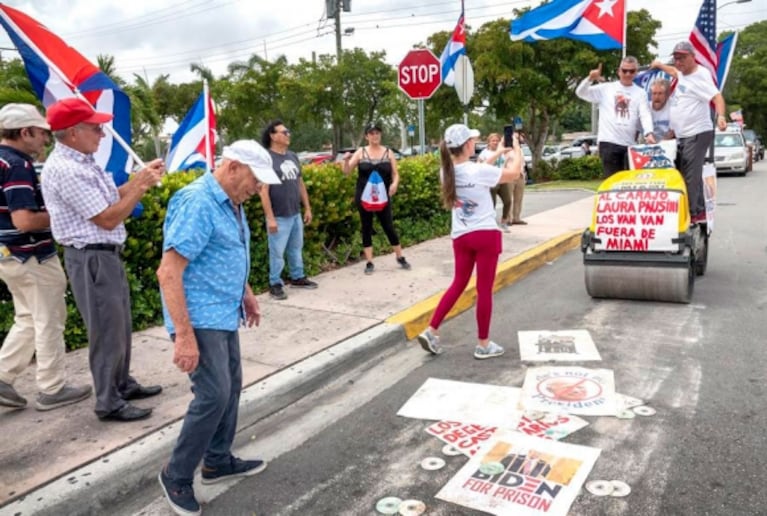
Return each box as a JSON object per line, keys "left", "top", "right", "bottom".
{"left": 509, "top": 0, "right": 626, "bottom": 50}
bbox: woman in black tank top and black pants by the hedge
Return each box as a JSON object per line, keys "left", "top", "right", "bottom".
{"left": 343, "top": 123, "right": 410, "bottom": 274}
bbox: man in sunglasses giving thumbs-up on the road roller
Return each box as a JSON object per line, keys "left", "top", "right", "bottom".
{"left": 575, "top": 56, "right": 655, "bottom": 177}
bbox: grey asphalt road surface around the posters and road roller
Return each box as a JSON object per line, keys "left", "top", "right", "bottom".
{"left": 135, "top": 162, "right": 767, "bottom": 516}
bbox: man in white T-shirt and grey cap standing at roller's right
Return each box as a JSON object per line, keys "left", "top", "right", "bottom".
{"left": 652, "top": 41, "right": 727, "bottom": 223}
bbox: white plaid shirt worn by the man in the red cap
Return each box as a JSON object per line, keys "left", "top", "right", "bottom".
{"left": 41, "top": 142, "right": 127, "bottom": 248}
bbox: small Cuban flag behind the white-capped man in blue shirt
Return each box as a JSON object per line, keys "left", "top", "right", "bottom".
{"left": 165, "top": 82, "right": 216, "bottom": 172}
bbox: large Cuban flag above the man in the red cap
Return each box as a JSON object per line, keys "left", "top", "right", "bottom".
{"left": 0, "top": 4, "right": 133, "bottom": 186}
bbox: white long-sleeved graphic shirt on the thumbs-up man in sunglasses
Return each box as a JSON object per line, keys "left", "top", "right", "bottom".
{"left": 575, "top": 77, "right": 652, "bottom": 146}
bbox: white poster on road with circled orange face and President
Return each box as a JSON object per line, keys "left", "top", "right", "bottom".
{"left": 522, "top": 366, "right": 618, "bottom": 416}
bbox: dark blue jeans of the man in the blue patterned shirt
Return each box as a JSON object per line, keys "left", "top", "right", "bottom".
{"left": 167, "top": 329, "right": 242, "bottom": 485}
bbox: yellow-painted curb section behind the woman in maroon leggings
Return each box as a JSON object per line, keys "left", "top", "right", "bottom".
{"left": 386, "top": 230, "right": 583, "bottom": 340}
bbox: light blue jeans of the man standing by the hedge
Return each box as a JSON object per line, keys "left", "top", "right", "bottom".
{"left": 267, "top": 213, "right": 304, "bottom": 285}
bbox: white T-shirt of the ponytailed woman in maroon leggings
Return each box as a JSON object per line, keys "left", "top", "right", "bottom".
{"left": 450, "top": 161, "right": 501, "bottom": 238}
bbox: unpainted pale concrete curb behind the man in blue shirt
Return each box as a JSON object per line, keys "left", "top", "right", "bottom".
{"left": 0, "top": 322, "right": 405, "bottom": 516}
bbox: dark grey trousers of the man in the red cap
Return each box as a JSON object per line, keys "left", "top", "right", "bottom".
{"left": 64, "top": 247, "right": 136, "bottom": 416}
